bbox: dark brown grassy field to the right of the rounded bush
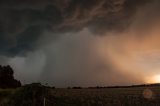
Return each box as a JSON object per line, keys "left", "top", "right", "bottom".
{"left": 46, "top": 88, "right": 160, "bottom": 106}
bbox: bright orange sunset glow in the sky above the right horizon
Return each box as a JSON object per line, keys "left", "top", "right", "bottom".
{"left": 94, "top": 22, "right": 160, "bottom": 83}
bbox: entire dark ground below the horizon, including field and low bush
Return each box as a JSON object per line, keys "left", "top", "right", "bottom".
{"left": 0, "top": 85, "right": 160, "bottom": 106}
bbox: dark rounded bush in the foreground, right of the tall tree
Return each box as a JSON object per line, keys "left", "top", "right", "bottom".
{"left": 11, "top": 83, "right": 45, "bottom": 106}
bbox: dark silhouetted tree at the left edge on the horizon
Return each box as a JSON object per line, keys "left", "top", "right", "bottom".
{"left": 0, "top": 65, "right": 21, "bottom": 88}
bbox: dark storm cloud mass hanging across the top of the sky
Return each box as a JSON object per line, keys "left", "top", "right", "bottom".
{"left": 0, "top": 0, "right": 155, "bottom": 56}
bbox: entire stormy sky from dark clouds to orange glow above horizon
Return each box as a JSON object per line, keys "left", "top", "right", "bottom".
{"left": 0, "top": 0, "right": 160, "bottom": 87}
